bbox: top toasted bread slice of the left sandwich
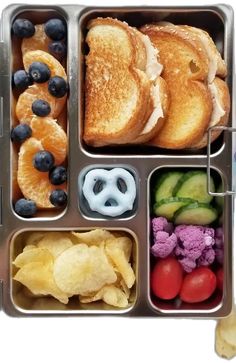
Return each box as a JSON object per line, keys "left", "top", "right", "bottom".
{"left": 83, "top": 18, "right": 152, "bottom": 146}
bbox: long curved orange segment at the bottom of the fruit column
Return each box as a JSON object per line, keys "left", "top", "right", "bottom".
{"left": 17, "top": 137, "right": 66, "bottom": 208}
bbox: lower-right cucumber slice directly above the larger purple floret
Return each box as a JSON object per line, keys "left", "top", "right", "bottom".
{"left": 174, "top": 202, "right": 218, "bottom": 226}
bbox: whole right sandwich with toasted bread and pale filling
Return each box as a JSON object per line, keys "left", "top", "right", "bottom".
{"left": 141, "top": 23, "right": 230, "bottom": 149}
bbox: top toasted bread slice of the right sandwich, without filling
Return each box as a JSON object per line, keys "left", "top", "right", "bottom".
{"left": 141, "top": 25, "right": 213, "bottom": 149}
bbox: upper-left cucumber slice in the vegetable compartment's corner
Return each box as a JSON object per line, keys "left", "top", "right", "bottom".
{"left": 155, "top": 171, "right": 184, "bottom": 202}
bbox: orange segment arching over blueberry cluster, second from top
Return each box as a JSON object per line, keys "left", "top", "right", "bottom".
{"left": 23, "top": 50, "right": 67, "bottom": 80}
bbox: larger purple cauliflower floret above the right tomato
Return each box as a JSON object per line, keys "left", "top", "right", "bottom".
{"left": 175, "top": 225, "right": 215, "bottom": 272}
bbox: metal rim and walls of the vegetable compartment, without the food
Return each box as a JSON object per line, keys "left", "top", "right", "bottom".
{"left": 149, "top": 165, "right": 232, "bottom": 314}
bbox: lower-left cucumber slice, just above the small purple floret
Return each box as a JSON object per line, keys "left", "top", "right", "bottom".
{"left": 154, "top": 197, "right": 194, "bottom": 220}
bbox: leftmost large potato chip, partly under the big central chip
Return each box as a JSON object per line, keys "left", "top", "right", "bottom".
{"left": 14, "top": 262, "right": 69, "bottom": 304}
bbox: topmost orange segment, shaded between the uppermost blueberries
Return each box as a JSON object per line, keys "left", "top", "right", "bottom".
{"left": 21, "top": 24, "right": 52, "bottom": 55}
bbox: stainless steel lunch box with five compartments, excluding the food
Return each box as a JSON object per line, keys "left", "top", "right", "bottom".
{"left": 0, "top": 5, "right": 234, "bottom": 318}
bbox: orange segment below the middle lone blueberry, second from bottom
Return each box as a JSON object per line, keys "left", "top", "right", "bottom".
{"left": 30, "top": 116, "right": 67, "bottom": 165}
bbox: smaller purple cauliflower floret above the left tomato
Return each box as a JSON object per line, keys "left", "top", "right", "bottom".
{"left": 151, "top": 232, "right": 177, "bottom": 258}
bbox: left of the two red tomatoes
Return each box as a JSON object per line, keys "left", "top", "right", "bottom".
{"left": 151, "top": 257, "right": 183, "bottom": 300}
